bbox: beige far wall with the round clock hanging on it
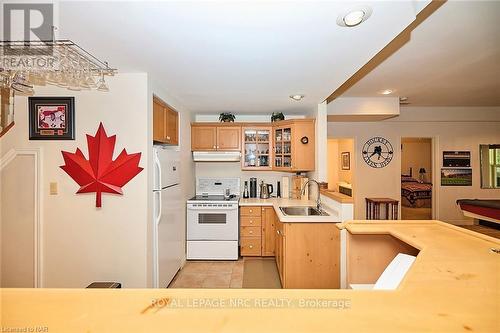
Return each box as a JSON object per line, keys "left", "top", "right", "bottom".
{"left": 328, "top": 107, "right": 500, "bottom": 224}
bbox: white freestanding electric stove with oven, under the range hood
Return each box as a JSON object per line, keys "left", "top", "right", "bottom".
{"left": 186, "top": 178, "right": 240, "bottom": 260}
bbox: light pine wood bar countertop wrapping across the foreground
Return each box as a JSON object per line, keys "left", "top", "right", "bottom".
{"left": 0, "top": 221, "right": 500, "bottom": 333}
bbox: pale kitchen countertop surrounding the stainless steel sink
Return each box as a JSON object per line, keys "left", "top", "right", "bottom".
{"left": 240, "top": 198, "right": 340, "bottom": 223}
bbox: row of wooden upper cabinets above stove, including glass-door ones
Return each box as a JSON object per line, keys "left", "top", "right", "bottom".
{"left": 191, "top": 119, "right": 315, "bottom": 172}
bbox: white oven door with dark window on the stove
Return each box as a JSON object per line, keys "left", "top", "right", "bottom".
{"left": 187, "top": 204, "right": 238, "bottom": 241}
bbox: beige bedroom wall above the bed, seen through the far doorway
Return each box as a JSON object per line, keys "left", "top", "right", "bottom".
{"left": 401, "top": 138, "right": 432, "bottom": 181}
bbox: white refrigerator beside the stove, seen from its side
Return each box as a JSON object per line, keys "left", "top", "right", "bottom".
{"left": 153, "top": 146, "right": 185, "bottom": 288}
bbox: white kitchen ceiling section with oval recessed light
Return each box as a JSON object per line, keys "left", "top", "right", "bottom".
{"left": 58, "top": 1, "right": 427, "bottom": 114}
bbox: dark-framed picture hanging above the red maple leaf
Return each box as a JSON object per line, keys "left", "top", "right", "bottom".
{"left": 28, "top": 97, "right": 75, "bottom": 140}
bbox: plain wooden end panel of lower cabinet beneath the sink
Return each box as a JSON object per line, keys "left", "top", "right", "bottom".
{"left": 275, "top": 221, "right": 340, "bottom": 289}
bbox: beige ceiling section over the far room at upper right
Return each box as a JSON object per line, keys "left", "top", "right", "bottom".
{"left": 342, "top": 1, "right": 500, "bottom": 106}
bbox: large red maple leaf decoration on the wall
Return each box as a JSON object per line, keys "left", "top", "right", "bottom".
{"left": 61, "top": 123, "right": 143, "bottom": 207}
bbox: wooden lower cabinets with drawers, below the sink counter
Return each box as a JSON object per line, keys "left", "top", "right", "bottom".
{"left": 240, "top": 206, "right": 340, "bottom": 289}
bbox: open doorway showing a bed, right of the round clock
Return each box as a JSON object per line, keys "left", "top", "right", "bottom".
{"left": 401, "top": 138, "right": 433, "bottom": 220}
